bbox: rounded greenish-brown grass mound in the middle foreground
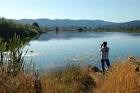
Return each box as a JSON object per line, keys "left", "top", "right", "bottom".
{"left": 42, "top": 65, "right": 95, "bottom": 93}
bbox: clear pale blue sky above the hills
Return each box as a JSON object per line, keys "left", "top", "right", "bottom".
{"left": 0, "top": 0, "right": 140, "bottom": 22}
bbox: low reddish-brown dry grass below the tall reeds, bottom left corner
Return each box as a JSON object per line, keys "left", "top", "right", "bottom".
{"left": 0, "top": 69, "right": 35, "bottom": 93}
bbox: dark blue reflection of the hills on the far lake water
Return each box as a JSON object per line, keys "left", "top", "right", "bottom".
{"left": 38, "top": 32, "right": 116, "bottom": 41}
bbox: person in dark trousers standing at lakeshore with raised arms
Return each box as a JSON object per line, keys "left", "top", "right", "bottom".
{"left": 101, "top": 42, "right": 110, "bottom": 74}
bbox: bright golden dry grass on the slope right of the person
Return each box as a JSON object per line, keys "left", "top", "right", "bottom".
{"left": 93, "top": 60, "right": 140, "bottom": 93}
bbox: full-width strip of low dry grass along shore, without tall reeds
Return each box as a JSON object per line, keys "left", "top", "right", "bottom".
{"left": 0, "top": 57, "right": 140, "bottom": 93}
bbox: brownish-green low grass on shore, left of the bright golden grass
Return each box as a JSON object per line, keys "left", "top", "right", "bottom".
{"left": 0, "top": 65, "right": 95, "bottom": 93}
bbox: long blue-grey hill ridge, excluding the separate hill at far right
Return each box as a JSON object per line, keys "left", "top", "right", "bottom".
{"left": 16, "top": 19, "right": 115, "bottom": 28}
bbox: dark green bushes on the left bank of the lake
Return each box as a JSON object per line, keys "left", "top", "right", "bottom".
{"left": 0, "top": 18, "right": 41, "bottom": 38}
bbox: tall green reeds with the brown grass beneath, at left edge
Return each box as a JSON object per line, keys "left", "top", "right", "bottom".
{"left": 0, "top": 36, "right": 36, "bottom": 93}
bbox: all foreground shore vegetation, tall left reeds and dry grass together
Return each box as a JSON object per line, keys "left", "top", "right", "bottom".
{"left": 0, "top": 36, "right": 140, "bottom": 93}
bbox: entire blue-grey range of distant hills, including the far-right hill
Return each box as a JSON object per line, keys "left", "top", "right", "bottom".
{"left": 15, "top": 19, "right": 140, "bottom": 29}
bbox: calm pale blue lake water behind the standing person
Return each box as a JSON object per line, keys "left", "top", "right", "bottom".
{"left": 24, "top": 32, "right": 140, "bottom": 68}
